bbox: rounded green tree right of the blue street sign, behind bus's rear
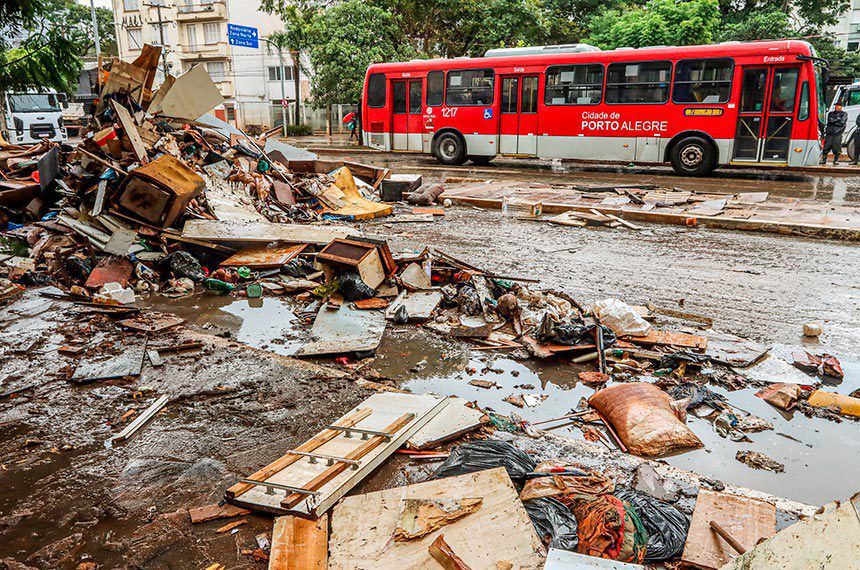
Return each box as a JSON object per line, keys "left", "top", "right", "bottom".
{"left": 308, "top": 0, "right": 415, "bottom": 108}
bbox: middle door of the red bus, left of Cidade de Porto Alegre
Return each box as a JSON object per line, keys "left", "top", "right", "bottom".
{"left": 498, "top": 75, "right": 538, "bottom": 156}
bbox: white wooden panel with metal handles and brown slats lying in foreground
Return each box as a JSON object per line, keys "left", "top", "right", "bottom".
{"left": 228, "top": 392, "right": 448, "bottom": 518}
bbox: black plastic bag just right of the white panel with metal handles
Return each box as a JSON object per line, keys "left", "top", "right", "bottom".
{"left": 433, "top": 440, "right": 536, "bottom": 490}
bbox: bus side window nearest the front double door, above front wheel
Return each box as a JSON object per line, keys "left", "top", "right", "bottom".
{"left": 672, "top": 59, "right": 734, "bottom": 104}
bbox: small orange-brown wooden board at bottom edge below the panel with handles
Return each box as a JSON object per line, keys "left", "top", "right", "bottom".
{"left": 269, "top": 514, "right": 328, "bottom": 570}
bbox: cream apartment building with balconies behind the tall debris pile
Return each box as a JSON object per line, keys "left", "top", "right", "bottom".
{"left": 111, "top": 0, "right": 310, "bottom": 128}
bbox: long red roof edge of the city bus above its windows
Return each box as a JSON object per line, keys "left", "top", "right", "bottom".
{"left": 368, "top": 40, "right": 813, "bottom": 73}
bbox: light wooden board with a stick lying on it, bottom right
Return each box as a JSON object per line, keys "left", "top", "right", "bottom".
{"left": 681, "top": 489, "right": 776, "bottom": 570}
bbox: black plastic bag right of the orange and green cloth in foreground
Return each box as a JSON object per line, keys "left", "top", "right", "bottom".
{"left": 615, "top": 487, "right": 690, "bottom": 562}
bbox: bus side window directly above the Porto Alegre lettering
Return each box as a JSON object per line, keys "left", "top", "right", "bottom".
{"left": 606, "top": 61, "right": 672, "bottom": 103}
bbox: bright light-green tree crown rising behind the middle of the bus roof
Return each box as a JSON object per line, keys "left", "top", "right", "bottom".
{"left": 587, "top": 0, "right": 720, "bottom": 49}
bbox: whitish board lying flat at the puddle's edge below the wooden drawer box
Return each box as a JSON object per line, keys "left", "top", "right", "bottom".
{"left": 295, "top": 303, "right": 388, "bottom": 356}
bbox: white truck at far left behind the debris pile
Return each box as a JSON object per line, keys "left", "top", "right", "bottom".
{"left": 5, "top": 90, "right": 68, "bottom": 144}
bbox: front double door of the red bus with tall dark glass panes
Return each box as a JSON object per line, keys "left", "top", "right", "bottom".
{"left": 733, "top": 67, "right": 800, "bottom": 163}
